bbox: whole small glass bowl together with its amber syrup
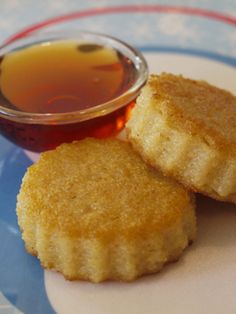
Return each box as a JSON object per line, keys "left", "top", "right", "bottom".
{"left": 0, "top": 30, "right": 148, "bottom": 152}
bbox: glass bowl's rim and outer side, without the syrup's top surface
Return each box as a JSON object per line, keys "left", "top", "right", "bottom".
{"left": 0, "top": 30, "right": 148, "bottom": 152}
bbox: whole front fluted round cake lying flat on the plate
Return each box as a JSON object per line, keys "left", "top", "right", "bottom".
{"left": 17, "top": 139, "right": 196, "bottom": 282}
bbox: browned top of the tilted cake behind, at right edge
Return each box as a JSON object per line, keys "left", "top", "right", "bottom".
{"left": 148, "top": 73, "right": 236, "bottom": 154}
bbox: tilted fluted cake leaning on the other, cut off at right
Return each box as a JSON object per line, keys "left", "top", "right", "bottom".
{"left": 127, "top": 73, "right": 236, "bottom": 203}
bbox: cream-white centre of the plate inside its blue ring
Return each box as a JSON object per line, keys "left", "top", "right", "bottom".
{"left": 45, "top": 53, "right": 236, "bottom": 314}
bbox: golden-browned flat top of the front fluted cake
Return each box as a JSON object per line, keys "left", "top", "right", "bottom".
{"left": 17, "top": 139, "right": 193, "bottom": 239}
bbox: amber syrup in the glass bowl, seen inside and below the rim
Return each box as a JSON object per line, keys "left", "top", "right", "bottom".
{"left": 0, "top": 41, "right": 137, "bottom": 152}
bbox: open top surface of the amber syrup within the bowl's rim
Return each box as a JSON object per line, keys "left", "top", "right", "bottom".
{"left": 0, "top": 41, "right": 137, "bottom": 113}
